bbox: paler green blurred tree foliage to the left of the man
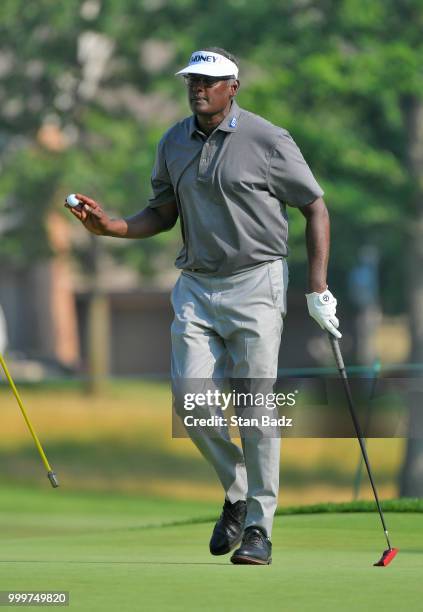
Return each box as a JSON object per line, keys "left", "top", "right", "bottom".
{"left": 0, "top": 0, "right": 185, "bottom": 274}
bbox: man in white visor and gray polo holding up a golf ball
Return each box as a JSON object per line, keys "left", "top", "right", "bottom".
{"left": 67, "top": 47, "right": 340, "bottom": 565}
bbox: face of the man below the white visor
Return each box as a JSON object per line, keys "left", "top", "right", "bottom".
{"left": 185, "top": 74, "right": 239, "bottom": 115}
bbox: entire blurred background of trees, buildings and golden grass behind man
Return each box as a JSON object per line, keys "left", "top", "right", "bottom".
{"left": 0, "top": 0, "right": 423, "bottom": 505}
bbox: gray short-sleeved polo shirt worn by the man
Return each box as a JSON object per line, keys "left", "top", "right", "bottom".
{"left": 149, "top": 100, "right": 323, "bottom": 276}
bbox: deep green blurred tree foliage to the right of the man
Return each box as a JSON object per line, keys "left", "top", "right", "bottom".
{"left": 186, "top": 0, "right": 423, "bottom": 495}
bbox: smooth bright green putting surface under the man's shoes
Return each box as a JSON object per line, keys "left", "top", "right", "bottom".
{"left": 0, "top": 489, "right": 423, "bottom": 612}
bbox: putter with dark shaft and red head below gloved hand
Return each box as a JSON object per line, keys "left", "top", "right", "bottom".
{"left": 328, "top": 332, "right": 398, "bottom": 567}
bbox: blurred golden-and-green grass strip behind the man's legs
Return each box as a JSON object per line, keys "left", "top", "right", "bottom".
{"left": 0, "top": 381, "right": 404, "bottom": 506}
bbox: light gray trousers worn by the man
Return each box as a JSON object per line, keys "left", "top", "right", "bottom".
{"left": 171, "top": 259, "right": 288, "bottom": 537}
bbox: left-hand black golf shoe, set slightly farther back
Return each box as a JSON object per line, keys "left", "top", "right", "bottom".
{"left": 209, "top": 499, "right": 247, "bottom": 555}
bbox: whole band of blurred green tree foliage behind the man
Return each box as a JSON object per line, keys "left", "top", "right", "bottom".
{"left": 0, "top": 0, "right": 423, "bottom": 312}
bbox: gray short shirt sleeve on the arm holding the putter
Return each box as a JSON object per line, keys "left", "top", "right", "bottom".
{"left": 267, "top": 130, "right": 324, "bottom": 207}
